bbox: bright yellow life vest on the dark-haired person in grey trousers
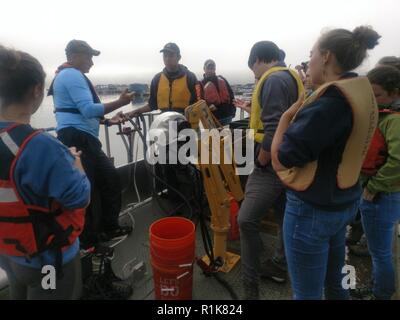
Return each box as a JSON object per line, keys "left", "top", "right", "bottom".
{"left": 250, "top": 67, "right": 304, "bottom": 143}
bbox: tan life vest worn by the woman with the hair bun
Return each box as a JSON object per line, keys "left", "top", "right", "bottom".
{"left": 277, "top": 77, "right": 378, "bottom": 191}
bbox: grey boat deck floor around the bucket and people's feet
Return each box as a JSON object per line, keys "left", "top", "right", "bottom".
{"left": 0, "top": 161, "right": 384, "bottom": 300}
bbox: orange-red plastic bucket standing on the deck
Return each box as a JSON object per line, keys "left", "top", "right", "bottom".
{"left": 150, "top": 217, "right": 196, "bottom": 300}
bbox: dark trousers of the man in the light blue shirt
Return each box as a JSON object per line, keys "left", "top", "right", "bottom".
{"left": 57, "top": 127, "right": 122, "bottom": 238}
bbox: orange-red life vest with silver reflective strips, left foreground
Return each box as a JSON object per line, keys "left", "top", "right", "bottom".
{"left": 0, "top": 124, "right": 85, "bottom": 258}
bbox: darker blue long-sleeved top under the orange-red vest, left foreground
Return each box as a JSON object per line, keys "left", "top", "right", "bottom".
{"left": 0, "top": 122, "right": 90, "bottom": 268}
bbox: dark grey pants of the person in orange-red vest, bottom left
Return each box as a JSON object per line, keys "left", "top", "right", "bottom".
{"left": 0, "top": 253, "right": 82, "bottom": 300}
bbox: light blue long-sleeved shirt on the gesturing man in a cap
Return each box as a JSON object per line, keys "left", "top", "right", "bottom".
{"left": 53, "top": 68, "right": 104, "bottom": 138}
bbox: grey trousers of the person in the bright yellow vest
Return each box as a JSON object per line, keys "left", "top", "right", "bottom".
{"left": 238, "top": 166, "right": 285, "bottom": 283}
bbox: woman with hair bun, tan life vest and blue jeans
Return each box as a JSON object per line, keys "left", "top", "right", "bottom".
{"left": 272, "top": 26, "right": 380, "bottom": 299}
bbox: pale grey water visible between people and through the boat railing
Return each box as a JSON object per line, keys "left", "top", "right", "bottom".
{"left": 31, "top": 95, "right": 244, "bottom": 166}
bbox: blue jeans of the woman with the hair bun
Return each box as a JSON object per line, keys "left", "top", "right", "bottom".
{"left": 283, "top": 191, "right": 359, "bottom": 300}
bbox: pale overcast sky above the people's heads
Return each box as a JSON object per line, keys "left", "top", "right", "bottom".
{"left": 0, "top": 0, "right": 400, "bottom": 83}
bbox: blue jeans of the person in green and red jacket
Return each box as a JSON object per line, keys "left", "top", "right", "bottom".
{"left": 360, "top": 192, "right": 400, "bottom": 300}
